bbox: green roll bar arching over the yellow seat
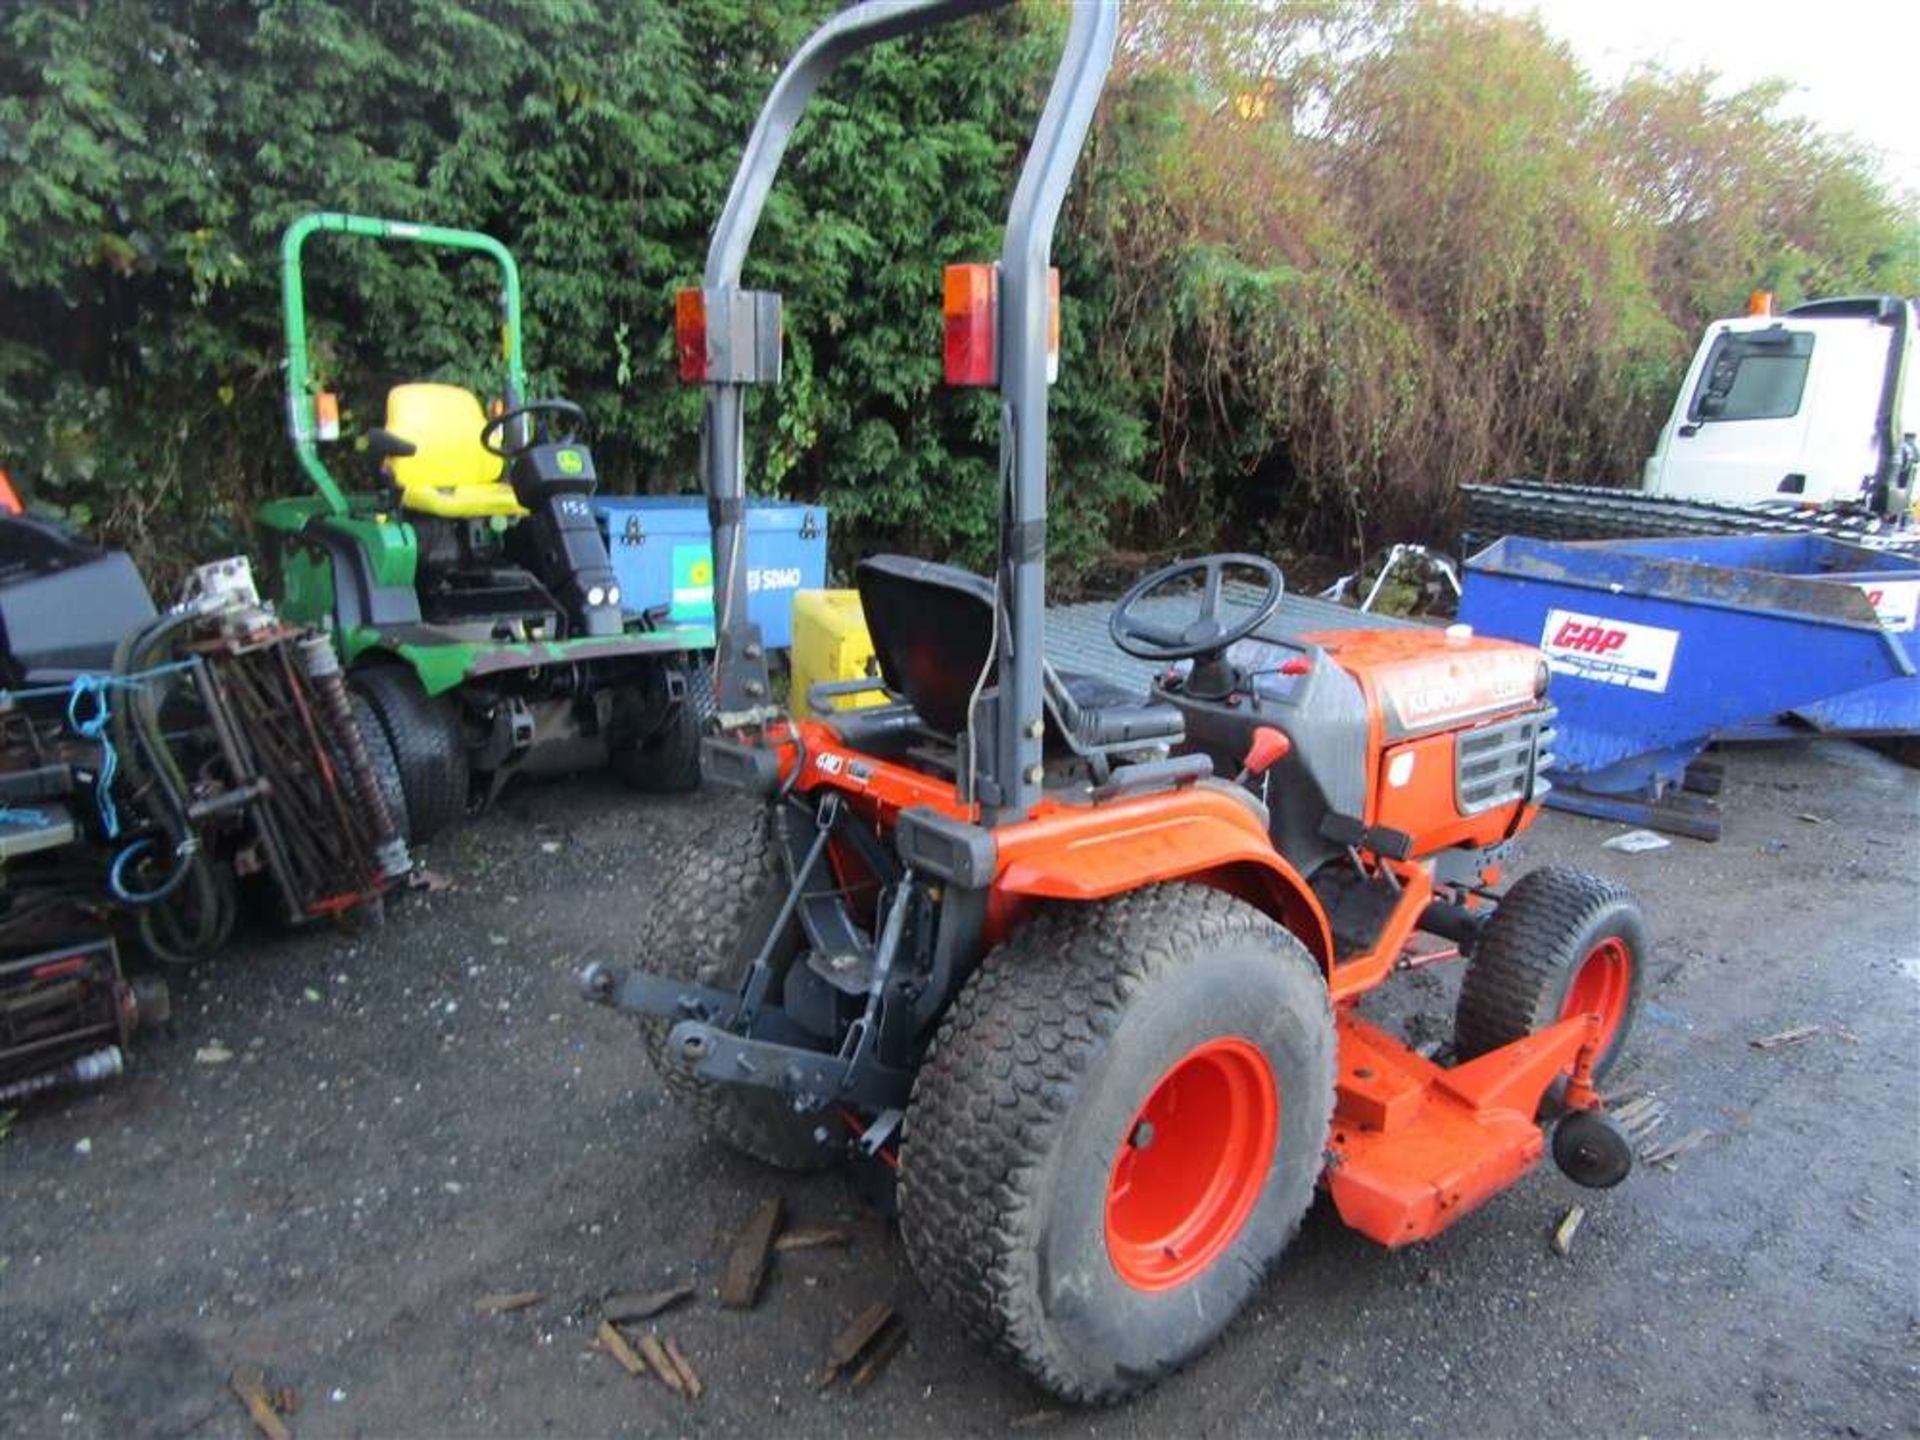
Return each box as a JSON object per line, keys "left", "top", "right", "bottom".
{"left": 280, "top": 211, "right": 526, "bottom": 515}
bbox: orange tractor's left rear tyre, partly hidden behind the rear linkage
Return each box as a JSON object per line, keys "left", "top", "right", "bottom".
{"left": 639, "top": 810, "right": 841, "bottom": 1169}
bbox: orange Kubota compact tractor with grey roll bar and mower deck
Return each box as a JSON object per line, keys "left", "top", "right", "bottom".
{"left": 584, "top": 0, "right": 1645, "bottom": 1400}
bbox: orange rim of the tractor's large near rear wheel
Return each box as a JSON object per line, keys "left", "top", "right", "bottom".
{"left": 1106, "top": 1039, "right": 1281, "bottom": 1290}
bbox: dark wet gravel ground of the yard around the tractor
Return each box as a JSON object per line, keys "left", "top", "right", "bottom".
{"left": 0, "top": 743, "right": 1920, "bottom": 1436}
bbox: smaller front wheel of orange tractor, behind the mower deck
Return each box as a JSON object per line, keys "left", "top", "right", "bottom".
{"left": 1453, "top": 866, "right": 1647, "bottom": 1079}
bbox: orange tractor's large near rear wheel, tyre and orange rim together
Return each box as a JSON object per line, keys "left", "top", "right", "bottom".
{"left": 900, "top": 885, "right": 1336, "bottom": 1402}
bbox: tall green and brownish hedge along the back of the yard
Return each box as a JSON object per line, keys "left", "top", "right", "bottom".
{"left": 0, "top": 0, "right": 1920, "bottom": 584}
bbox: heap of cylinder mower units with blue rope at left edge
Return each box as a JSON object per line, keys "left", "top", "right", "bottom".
{"left": 0, "top": 516, "right": 411, "bottom": 1100}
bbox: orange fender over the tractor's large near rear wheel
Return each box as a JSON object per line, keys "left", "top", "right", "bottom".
{"left": 993, "top": 785, "right": 1334, "bottom": 970}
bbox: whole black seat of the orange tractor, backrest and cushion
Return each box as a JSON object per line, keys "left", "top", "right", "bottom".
{"left": 854, "top": 555, "right": 1183, "bottom": 753}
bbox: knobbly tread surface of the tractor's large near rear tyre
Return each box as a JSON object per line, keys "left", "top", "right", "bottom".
{"left": 899, "top": 883, "right": 1336, "bottom": 1404}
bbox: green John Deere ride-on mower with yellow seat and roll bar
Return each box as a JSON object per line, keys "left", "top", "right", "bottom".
{"left": 259, "top": 213, "right": 712, "bottom": 841}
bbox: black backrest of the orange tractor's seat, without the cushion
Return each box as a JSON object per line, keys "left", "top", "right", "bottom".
{"left": 854, "top": 555, "right": 993, "bottom": 735}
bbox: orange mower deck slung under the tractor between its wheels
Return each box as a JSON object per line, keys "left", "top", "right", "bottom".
{"left": 1325, "top": 1010, "right": 1599, "bottom": 1248}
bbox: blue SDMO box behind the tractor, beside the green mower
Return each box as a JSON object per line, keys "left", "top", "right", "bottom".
{"left": 593, "top": 495, "right": 828, "bottom": 649}
